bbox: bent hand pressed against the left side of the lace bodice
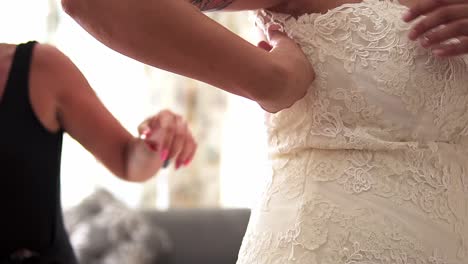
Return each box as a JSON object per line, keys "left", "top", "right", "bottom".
{"left": 257, "top": 25, "right": 315, "bottom": 113}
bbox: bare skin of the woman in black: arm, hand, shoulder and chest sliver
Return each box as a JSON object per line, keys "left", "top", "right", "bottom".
{"left": 0, "top": 44, "right": 196, "bottom": 182}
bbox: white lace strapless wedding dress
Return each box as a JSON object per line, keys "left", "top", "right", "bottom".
{"left": 238, "top": 0, "right": 468, "bottom": 264}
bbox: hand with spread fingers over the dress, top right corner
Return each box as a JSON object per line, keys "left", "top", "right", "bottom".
{"left": 403, "top": 0, "right": 468, "bottom": 57}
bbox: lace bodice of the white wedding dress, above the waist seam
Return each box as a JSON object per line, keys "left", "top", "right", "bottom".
{"left": 254, "top": 0, "right": 468, "bottom": 152}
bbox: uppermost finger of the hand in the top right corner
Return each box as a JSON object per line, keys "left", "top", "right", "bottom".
{"left": 409, "top": 4, "right": 468, "bottom": 40}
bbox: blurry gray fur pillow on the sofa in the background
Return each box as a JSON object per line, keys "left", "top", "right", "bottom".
{"left": 64, "top": 190, "right": 171, "bottom": 264}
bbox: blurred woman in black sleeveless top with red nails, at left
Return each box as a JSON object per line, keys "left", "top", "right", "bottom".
{"left": 0, "top": 42, "right": 196, "bottom": 264}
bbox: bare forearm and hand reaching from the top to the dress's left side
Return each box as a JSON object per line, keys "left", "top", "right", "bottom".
{"left": 62, "top": 0, "right": 314, "bottom": 112}
